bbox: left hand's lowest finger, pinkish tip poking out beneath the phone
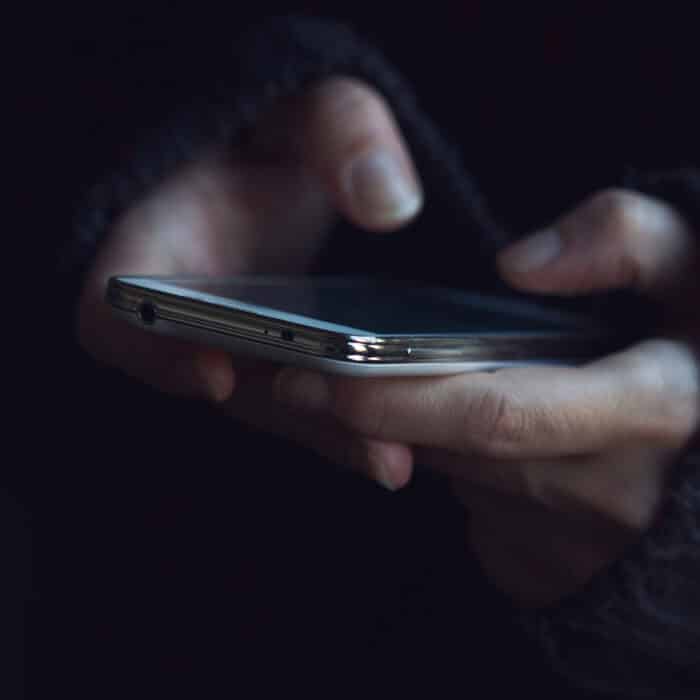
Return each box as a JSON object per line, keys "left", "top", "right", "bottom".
{"left": 225, "top": 363, "right": 413, "bottom": 491}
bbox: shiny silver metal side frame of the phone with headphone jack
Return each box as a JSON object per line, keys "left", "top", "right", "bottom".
{"left": 106, "top": 277, "right": 611, "bottom": 366}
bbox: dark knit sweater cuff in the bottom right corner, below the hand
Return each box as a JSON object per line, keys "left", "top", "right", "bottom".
{"left": 521, "top": 452, "right": 700, "bottom": 700}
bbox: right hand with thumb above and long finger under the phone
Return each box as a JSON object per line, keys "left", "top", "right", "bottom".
{"left": 277, "top": 191, "right": 700, "bottom": 605}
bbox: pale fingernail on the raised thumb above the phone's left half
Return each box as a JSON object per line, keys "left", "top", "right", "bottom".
{"left": 348, "top": 151, "right": 422, "bottom": 223}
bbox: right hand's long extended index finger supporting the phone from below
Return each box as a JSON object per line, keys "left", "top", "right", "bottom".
{"left": 277, "top": 341, "right": 698, "bottom": 459}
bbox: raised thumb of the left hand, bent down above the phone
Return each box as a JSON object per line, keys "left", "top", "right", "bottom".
{"left": 302, "top": 78, "right": 423, "bottom": 231}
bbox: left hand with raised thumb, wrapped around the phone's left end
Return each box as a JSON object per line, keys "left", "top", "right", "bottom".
{"left": 78, "top": 78, "right": 422, "bottom": 482}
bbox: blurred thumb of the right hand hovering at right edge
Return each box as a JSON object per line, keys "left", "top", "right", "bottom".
{"left": 499, "top": 190, "right": 696, "bottom": 294}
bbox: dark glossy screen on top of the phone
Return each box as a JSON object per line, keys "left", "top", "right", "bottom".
{"left": 149, "top": 277, "right": 592, "bottom": 336}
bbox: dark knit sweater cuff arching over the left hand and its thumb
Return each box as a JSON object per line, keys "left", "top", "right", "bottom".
{"left": 61, "top": 17, "right": 506, "bottom": 302}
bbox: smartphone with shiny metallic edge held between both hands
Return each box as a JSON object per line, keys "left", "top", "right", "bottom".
{"left": 107, "top": 276, "right": 614, "bottom": 376}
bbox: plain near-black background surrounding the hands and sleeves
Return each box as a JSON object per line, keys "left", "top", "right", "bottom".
{"left": 10, "top": 2, "right": 697, "bottom": 698}
